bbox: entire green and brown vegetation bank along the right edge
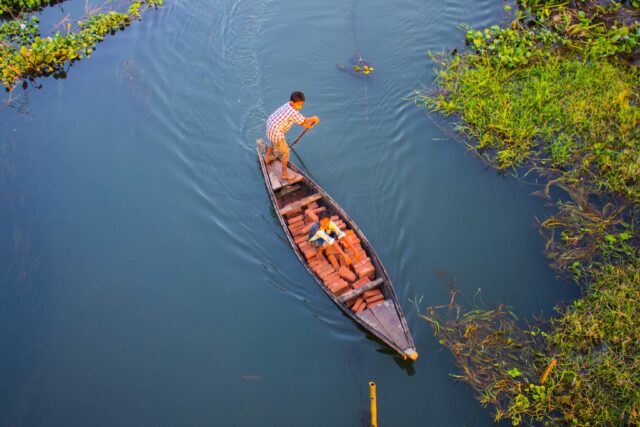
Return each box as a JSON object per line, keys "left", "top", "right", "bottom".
{"left": 415, "top": 0, "right": 640, "bottom": 426}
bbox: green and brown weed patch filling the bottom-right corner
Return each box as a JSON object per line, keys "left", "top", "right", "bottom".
{"left": 422, "top": 258, "right": 640, "bottom": 426}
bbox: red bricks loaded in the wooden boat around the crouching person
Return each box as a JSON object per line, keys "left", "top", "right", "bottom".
{"left": 287, "top": 202, "right": 384, "bottom": 313}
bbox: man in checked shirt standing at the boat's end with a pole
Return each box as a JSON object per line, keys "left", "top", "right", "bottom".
{"left": 265, "top": 92, "right": 320, "bottom": 179}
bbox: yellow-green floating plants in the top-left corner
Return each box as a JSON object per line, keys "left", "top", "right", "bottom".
{"left": 0, "top": 0, "right": 163, "bottom": 91}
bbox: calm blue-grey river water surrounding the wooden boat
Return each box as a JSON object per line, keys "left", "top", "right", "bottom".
{"left": 0, "top": 0, "right": 574, "bottom": 427}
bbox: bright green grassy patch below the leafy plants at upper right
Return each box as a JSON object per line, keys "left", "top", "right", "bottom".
{"left": 415, "top": 55, "right": 640, "bottom": 201}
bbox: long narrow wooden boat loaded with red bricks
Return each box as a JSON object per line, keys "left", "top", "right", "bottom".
{"left": 257, "top": 139, "right": 418, "bottom": 360}
